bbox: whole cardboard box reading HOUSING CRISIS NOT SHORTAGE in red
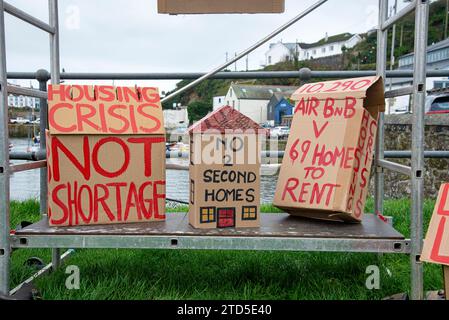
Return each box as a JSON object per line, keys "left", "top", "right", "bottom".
{"left": 47, "top": 85, "right": 165, "bottom": 226}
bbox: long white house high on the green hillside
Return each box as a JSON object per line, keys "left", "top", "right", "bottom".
{"left": 265, "top": 33, "right": 362, "bottom": 65}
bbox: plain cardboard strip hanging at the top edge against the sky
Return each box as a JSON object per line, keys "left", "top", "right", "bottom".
{"left": 157, "top": 0, "right": 285, "bottom": 14}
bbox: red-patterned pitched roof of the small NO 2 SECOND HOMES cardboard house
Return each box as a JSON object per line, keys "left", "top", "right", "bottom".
{"left": 188, "top": 106, "right": 265, "bottom": 134}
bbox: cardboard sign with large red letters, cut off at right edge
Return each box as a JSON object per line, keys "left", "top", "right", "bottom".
{"left": 421, "top": 183, "right": 449, "bottom": 266}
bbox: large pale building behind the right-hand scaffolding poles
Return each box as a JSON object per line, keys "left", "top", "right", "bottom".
{"left": 386, "top": 39, "right": 449, "bottom": 113}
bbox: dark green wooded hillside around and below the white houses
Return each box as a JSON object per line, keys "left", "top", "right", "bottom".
{"left": 163, "top": 0, "right": 446, "bottom": 122}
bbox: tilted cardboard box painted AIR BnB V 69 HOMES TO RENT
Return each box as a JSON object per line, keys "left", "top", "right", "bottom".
{"left": 273, "top": 77, "right": 385, "bottom": 222}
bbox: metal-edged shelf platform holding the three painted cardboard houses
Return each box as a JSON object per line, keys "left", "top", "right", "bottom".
{"left": 11, "top": 213, "right": 410, "bottom": 253}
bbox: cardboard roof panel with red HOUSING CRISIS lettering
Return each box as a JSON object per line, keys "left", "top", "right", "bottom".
{"left": 48, "top": 84, "right": 165, "bottom": 135}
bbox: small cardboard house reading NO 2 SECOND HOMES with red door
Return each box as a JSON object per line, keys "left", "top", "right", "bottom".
{"left": 189, "top": 106, "right": 265, "bottom": 228}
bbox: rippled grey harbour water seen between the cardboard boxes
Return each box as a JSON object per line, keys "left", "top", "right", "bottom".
{"left": 10, "top": 139, "right": 277, "bottom": 203}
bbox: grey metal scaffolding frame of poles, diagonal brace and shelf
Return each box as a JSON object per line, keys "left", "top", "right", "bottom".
{"left": 0, "top": 0, "right": 430, "bottom": 299}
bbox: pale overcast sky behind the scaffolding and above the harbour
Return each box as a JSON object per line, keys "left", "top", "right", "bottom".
{"left": 6, "top": 0, "right": 410, "bottom": 90}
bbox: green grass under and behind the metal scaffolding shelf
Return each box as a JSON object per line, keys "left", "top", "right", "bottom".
{"left": 11, "top": 200, "right": 443, "bottom": 299}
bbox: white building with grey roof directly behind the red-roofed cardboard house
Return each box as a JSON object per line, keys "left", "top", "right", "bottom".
{"left": 224, "top": 84, "right": 298, "bottom": 124}
